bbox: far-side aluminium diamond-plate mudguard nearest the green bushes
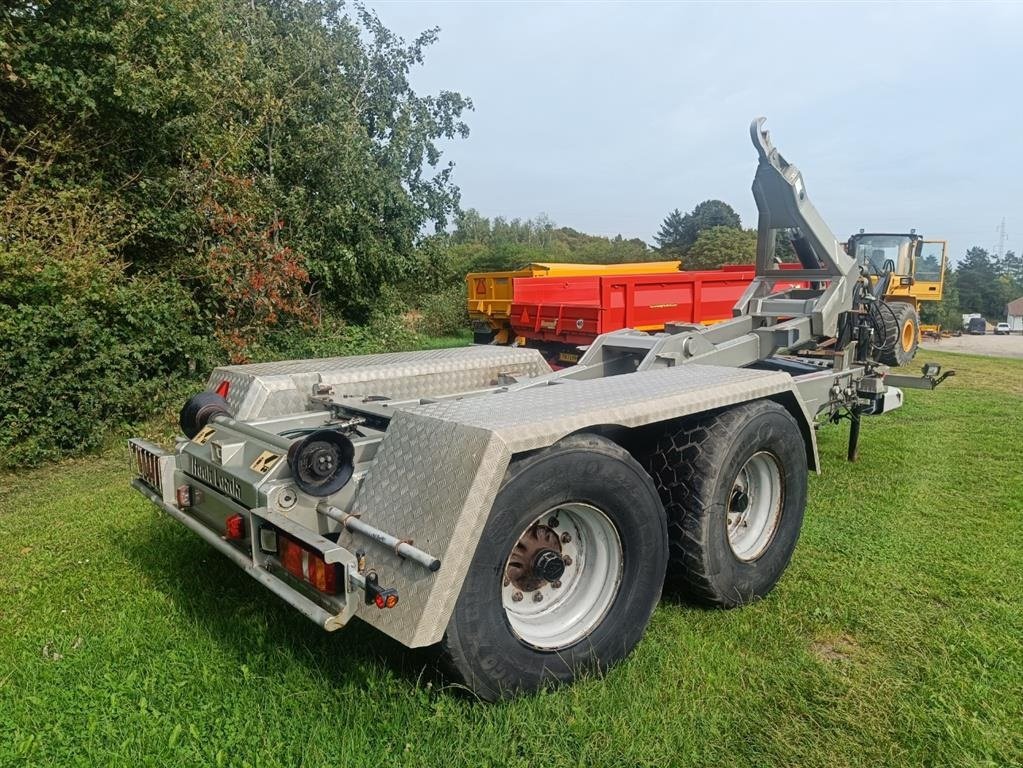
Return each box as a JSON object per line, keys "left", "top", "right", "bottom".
{"left": 201, "top": 346, "right": 550, "bottom": 420}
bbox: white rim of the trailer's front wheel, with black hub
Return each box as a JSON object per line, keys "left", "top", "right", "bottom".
{"left": 727, "top": 451, "right": 784, "bottom": 561}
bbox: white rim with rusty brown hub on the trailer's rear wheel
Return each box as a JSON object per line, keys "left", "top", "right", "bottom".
{"left": 501, "top": 503, "right": 624, "bottom": 650}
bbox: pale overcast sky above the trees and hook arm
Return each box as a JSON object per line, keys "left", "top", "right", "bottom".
{"left": 370, "top": 0, "right": 1023, "bottom": 258}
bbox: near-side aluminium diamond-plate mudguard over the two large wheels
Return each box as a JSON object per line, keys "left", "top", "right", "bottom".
{"left": 345, "top": 365, "right": 814, "bottom": 646}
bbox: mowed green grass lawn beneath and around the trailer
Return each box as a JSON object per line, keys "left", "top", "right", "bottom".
{"left": 0, "top": 353, "right": 1023, "bottom": 767}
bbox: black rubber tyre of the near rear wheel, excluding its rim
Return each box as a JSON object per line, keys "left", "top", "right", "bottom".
{"left": 440, "top": 435, "right": 668, "bottom": 701}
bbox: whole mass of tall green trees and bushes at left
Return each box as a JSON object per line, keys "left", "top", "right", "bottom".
{"left": 0, "top": 0, "right": 472, "bottom": 462}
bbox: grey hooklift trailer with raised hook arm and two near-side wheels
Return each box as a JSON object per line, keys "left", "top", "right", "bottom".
{"left": 130, "top": 119, "right": 947, "bottom": 699}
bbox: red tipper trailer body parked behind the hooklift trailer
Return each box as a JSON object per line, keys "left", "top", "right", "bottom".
{"left": 510, "top": 265, "right": 754, "bottom": 346}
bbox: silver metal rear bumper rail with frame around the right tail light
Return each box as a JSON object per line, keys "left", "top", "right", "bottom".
{"left": 132, "top": 478, "right": 361, "bottom": 632}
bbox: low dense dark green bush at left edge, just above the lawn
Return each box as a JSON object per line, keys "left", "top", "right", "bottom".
{"left": 0, "top": 279, "right": 210, "bottom": 466}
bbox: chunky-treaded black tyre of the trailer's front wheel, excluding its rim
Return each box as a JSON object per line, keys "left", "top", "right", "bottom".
{"left": 647, "top": 400, "right": 807, "bottom": 607}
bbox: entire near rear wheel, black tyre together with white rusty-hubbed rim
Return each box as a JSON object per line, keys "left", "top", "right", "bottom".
{"left": 439, "top": 434, "right": 668, "bottom": 701}
